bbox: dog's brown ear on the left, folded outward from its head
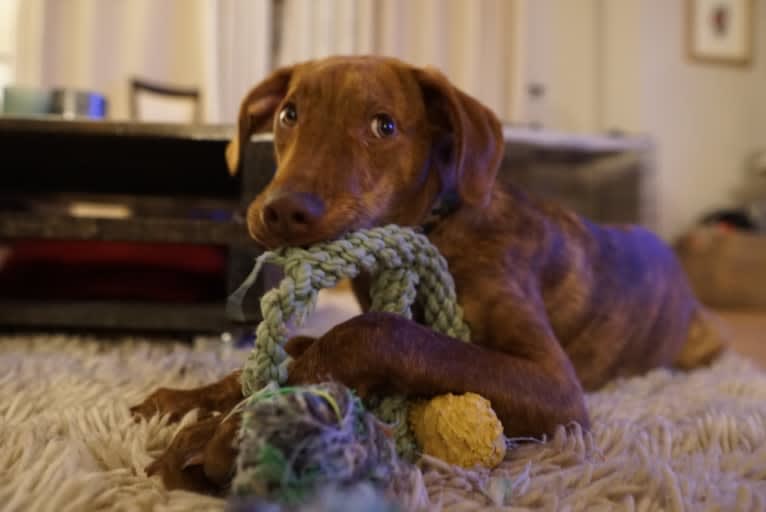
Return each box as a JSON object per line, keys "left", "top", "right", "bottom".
{"left": 226, "top": 66, "right": 295, "bottom": 175}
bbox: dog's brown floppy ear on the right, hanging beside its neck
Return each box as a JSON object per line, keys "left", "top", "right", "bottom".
{"left": 414, "top": 69, "right": 504, "bottom": 206}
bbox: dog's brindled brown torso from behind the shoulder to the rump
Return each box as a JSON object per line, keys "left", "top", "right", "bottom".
{"left": 436, "top": 184, "right": 724, "bottom": 389}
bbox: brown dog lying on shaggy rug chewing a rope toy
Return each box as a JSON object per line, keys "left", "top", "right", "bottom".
{"left": 134, "top": 57, "right": 722, "bottom": 488}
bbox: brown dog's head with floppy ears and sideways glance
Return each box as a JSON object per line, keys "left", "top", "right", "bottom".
{"left": 226, "top": 57, "right": 503, "bottom": 248}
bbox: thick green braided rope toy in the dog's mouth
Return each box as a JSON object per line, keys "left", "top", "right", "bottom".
{"left": 225, "top": 225, "right": 470, "bottom": 459}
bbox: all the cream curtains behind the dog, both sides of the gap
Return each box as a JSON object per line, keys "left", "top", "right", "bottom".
{"left": 12, "top": 0, "right": 519, "bottom": 122}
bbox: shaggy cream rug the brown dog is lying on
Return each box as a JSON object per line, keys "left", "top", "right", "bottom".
{"left": 0, "top": 336, "right": 766, "bottom": 512}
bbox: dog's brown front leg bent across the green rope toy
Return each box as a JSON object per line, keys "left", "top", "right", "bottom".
{"left": 287, "top": 313, "right": 589, "bottom": 436}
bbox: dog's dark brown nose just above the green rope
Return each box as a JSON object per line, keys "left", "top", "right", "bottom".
{"left": 262, "top": 192, "right": 324, "bottom": 238}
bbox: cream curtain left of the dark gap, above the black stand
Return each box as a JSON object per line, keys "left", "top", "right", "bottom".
{"left": 13, "top": 0, "right": 271, "bottom": 122}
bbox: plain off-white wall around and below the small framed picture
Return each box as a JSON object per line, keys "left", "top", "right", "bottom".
{"left": 635, "top": 0, "right": 766, "bottom": 237}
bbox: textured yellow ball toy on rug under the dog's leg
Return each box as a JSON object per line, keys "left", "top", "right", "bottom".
{"left": 409, "top": 393, "right": 506, "bottom": 468}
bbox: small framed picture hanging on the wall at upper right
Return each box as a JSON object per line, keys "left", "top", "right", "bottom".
{"left": 686, "top": 0, "right": 755, "bottom": 66}
